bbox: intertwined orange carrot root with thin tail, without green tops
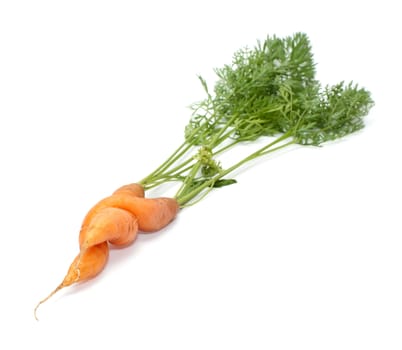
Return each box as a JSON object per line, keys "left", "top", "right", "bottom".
{"left": 34, "top": 184, "right": 179, "bottom": 319}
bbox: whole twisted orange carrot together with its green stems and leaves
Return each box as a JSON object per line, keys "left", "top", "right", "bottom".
{"left": 35, "top": 33, "right": 374, "bottom": 320}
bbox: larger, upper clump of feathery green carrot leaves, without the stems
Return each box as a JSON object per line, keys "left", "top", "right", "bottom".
{"left": 186, "top": 33, "right": 315, "bottom": 146}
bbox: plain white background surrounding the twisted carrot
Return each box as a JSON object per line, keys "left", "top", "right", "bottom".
{"left": 0, "top": 0, "right": 402, "bottom": 350}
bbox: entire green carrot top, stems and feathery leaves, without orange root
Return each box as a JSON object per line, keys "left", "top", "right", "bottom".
{"left": 140, "top": 33, "right": 373, "bottom": 207}
